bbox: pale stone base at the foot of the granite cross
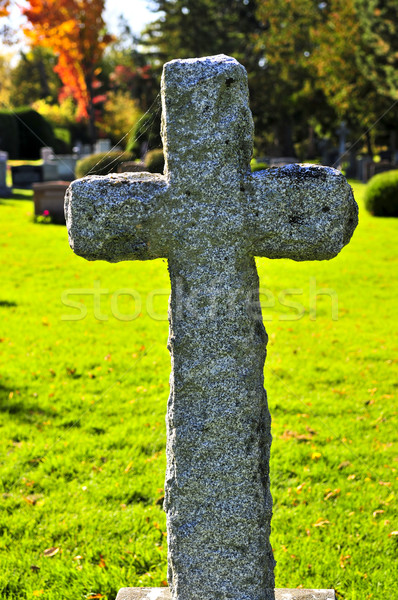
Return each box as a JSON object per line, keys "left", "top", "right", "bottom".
{"left": 116, "top": 587, "right": 336, "bottom": 600}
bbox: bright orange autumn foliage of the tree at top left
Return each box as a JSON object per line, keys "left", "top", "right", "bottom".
{"left": 22, "top": 0, "right": 113, "bottom": 141}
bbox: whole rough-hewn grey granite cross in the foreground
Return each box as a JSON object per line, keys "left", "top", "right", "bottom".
{"left": 65, "top": 55, "right": 357, "bottom": 600}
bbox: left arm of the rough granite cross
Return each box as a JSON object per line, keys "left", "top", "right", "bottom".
{"left": 65, "top": 173, "right": 168, "bottom": 262}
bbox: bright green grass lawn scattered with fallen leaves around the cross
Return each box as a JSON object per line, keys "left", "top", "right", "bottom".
{"left": 0, "top": 184, "right": 398, "bottom": 600}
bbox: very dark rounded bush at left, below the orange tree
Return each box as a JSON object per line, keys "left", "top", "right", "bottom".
{"left": 15, "top": 108, "right": 55, "bottom": 160}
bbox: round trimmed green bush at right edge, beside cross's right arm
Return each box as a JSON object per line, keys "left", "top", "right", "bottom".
{"left": 365, "top": 169, "right": 398, "bottom": 217}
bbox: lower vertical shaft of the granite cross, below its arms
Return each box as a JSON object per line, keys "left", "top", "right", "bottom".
{"left": 165, "top": 248, "right": 274, "bottom": 600}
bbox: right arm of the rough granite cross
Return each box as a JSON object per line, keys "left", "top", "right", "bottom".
{"left": 242, "top": 164, "right": 358, "bottom": 261}
